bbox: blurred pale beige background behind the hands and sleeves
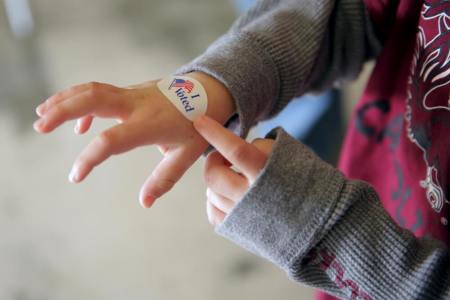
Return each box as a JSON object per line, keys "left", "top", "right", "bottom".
{"left": 0, "top": 0, "right": 370, "bottom": 300}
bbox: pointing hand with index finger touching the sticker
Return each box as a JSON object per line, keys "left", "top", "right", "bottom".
{"left": 194, "top": 116, "right": 274, "bottom": 225}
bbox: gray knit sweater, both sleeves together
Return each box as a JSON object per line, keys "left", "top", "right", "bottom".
{"left": 177, "top": 0, "right": 450, "bottom": 299}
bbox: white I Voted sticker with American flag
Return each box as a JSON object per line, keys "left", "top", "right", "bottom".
{"left": 157, "top": 76, "right": 208, "bottom": 121}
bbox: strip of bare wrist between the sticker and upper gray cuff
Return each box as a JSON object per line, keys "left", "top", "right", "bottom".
{"left": 184, "top": 72, "right": 236, "bottom": 124}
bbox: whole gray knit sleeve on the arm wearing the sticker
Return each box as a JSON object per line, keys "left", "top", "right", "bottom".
{"left": 176, "top": 0, "right": 380, "bottom": 136}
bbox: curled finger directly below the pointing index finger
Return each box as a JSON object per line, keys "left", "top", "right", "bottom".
{"left": 204, "top": 151, "right": 249, "bottom": 202}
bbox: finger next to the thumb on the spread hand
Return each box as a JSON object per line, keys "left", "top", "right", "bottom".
{"left": 69, "top": 123, "right": 147, "bottom": 183}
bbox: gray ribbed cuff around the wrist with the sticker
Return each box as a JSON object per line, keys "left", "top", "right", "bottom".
{"left": 176, "top": 33, "right": 278, "bottom": 137}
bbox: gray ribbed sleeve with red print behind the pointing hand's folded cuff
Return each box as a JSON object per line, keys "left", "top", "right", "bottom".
{"left": 298, "top": 181, "right": 450, "bottom": 299}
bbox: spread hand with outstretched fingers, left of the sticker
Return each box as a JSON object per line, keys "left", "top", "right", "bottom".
{"left": 34, "top": 81, "right": 217, "bottom": 207}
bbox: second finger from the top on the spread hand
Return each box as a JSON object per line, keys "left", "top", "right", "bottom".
{"left": 34, "top": 91, "right": 128, "bottom": 133}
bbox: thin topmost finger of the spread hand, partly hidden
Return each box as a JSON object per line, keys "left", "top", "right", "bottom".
{"left": 36, "top": 82, "right": 117, "bottom": 117}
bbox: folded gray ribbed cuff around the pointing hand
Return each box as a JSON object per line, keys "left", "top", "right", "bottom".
{"left": 216, "top": 129, "right": 344, "bottom": 271}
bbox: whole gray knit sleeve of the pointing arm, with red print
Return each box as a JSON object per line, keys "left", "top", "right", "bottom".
{"left": 216, "top": 129, "right": 450, "bottom": 299}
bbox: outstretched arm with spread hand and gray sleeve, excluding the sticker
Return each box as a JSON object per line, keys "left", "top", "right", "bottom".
{"left": 34, "top": 0, "right": 380, "bottom": 207}
